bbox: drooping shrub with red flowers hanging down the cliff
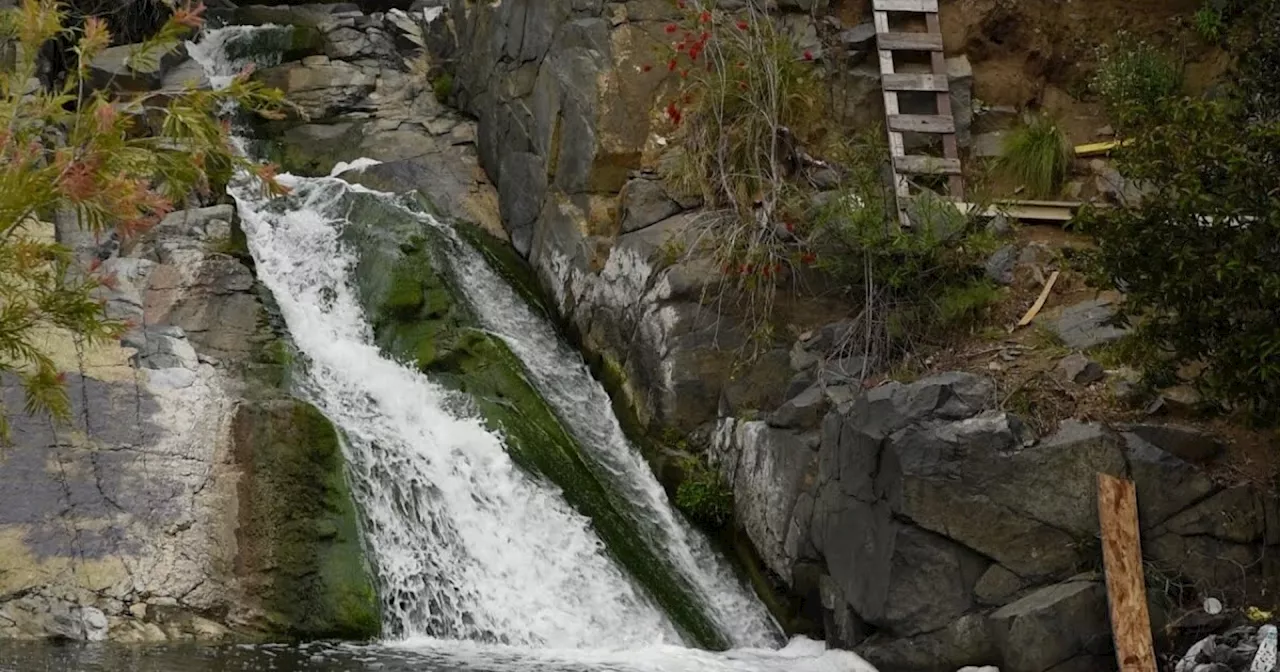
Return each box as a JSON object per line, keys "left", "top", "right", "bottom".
{"left": 660, "top": 0, "right": 822, "bottom": 355}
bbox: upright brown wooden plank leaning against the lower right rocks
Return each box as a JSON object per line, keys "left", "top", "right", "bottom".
{"left": 1098, "top": 474, "right": 1156, "bottom": 672}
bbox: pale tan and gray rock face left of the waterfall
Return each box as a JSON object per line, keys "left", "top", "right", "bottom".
{"left": 0, "top": 215, "right": 378, "bottom": 641}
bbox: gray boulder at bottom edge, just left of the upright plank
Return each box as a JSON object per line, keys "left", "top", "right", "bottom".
{"left": 989, "top": 581, "right": 1111, "bottom": 672}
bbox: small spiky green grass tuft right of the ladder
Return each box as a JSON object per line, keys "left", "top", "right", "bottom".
{"left": 996, "top": 115, "right": 1075, "bottom": 198}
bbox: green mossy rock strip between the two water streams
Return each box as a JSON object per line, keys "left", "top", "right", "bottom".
{"left": 344, "top": 204, "right": 728, "bottom": 649}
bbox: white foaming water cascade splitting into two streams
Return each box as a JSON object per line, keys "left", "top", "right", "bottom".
{"left": 191, "top": 27, "right": 874, "bottom": 672}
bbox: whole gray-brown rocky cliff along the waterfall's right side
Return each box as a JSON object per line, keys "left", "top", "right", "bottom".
{"left": 230, "top": 0, "right": 1280, "bottom": 672}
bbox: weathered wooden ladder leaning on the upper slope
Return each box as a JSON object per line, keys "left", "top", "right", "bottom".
{"left": 872, "top": 0, "right": 964, "bottom": 225}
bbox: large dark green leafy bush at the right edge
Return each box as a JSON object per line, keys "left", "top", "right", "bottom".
{"left": 1088, "top": 0, "right": 1280, "bottom": 420}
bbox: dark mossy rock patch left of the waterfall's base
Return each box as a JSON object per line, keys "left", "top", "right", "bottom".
{"left": 233, "top": 399, "right": 380, "bottom": 640}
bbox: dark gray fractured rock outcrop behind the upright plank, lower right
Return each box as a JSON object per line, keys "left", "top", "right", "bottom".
{"left": 713, "top": 371, "right": 1280, "bottom": 672}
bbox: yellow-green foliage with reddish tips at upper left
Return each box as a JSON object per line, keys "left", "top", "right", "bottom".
{"left": 0, "top": 0, "right": 283, "bottom": 435}
